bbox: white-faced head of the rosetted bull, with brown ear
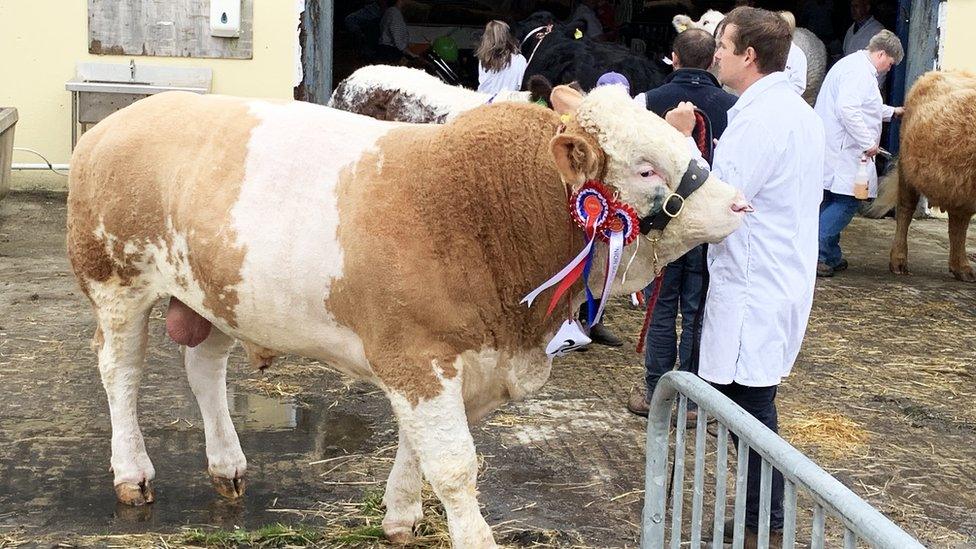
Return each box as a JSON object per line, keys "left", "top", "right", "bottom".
{"left": 551, "top": 86, "right": 748, "bottom": 282}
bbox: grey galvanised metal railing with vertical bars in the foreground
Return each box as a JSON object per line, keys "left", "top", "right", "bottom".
{"left": 641, "top": 372, "right": 923, "bottom": 549}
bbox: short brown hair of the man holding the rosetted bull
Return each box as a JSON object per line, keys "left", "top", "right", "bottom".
{"left": 716, "top": 6, "right": 792, "bottom": 74}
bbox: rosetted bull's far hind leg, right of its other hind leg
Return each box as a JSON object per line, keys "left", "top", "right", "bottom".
{"left": 186, "top": 328, "right": 247, "bottom": 499}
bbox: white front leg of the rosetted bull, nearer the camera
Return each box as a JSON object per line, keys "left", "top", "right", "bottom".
{"left": 390, "top": 359, "right": 496, "bottom": 549}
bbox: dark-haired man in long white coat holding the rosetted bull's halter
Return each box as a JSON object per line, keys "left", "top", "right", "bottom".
{"left": 666, "top": 7, "right": 824, "bottom": 547}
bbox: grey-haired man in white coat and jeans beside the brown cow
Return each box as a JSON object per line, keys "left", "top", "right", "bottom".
{"left": 815, "top": 30, "right": 905, "bottom": 276}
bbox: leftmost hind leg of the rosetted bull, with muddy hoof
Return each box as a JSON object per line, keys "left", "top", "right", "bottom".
{"left": 89, "top": 283, "right": 156, "bottom": 505}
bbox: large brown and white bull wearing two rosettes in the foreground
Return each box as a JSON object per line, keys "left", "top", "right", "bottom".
{"left": 68, "top": 86, "right": 743, "bottom": 548}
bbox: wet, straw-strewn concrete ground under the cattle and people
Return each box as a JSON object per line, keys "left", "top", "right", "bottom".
{"left": 0, "top": 192, "right": 976, "bottom": 547}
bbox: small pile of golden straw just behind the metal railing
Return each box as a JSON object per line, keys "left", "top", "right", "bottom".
{"left": 780, "top": 410, "right": 869, "bottom": 459}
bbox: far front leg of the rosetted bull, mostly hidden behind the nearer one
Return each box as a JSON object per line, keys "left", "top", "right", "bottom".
{"left": 383, "top": 429, "right": 424, "bottom": 544}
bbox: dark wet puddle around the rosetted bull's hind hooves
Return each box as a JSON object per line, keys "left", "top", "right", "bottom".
{"left": 0, "top": 388, "right": 373, "bottom": 534}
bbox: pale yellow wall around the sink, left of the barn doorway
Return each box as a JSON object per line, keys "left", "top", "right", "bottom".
{"left": 0, "top": 0, "right": 298, "bottom": 167}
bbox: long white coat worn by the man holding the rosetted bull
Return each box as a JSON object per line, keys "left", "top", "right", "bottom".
{"left": 698, "top": 72, "right": 824, "bottom": 387}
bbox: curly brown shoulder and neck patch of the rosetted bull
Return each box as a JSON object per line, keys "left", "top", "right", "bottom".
{"left": 326, "top": 104, "right": 603, "bottom": 401}
